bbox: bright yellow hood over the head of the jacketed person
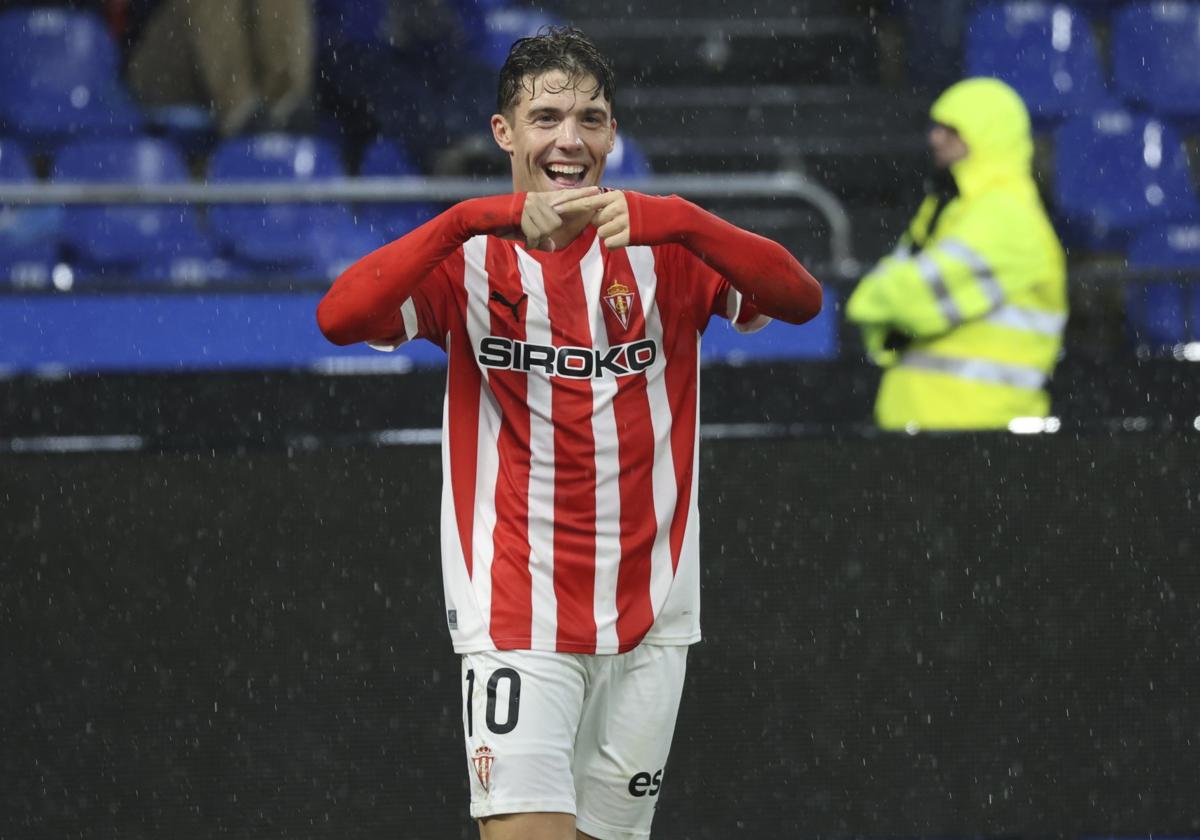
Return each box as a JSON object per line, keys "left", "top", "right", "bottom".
{"left": 929, "top": 78, "right": 1033, "bottom": 197}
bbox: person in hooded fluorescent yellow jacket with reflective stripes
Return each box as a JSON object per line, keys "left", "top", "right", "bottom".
{"left": 846, "top": 78, "right": 1067, "bottom": 431}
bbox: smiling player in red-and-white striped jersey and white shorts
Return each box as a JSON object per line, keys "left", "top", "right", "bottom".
{"left": 317, "top": 29, "right": 821, "bottom": 840}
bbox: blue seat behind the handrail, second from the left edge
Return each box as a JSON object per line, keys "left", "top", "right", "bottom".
{"left": 52, "top": 137, "right": 220, "bottom": 280}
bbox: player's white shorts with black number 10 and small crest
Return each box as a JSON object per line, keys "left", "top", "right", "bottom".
{"left": 462, "top": 644, "right": 688, "bottom": 840}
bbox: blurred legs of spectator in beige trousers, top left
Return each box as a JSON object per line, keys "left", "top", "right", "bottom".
{"left": 128, "top": 0, "right": 316, "bottom": 137}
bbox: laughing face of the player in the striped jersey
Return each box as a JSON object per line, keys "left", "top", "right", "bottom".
{"left": 492, "top": 70, "right": 617, "bottom": 192}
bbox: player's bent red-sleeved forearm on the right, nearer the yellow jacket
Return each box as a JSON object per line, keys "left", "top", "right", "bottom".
{"left": 626, "top": 193, "right": 822, "bottom": 324}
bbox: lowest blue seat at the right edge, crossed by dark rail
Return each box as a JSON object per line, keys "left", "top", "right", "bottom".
{"left": 1126, "top": 221, "right": 1200, "bottom": 350}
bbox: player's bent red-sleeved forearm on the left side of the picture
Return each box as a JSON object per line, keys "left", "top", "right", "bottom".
{"left": 317, "top": 193, "right": 524, "bottom": 344}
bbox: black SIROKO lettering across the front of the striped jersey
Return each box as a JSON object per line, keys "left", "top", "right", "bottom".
{"left": 476, "top": 336, "right": 659, "bottom": 379}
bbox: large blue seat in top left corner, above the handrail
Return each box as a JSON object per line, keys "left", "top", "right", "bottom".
{"left": 0, "top": 8, "right": 142, "bottom": 143}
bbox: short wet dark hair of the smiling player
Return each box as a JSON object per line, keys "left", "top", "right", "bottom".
{"left": 496, "top": 26, "right": 617, "bottom": 114}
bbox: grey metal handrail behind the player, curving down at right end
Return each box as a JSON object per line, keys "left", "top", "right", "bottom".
{"left": 0, "top": 172, "right": 858, "bottom": 276}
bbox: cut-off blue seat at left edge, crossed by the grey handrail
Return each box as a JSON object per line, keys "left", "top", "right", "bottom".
{"left": 0, "top": 139, "right": 62, "bottom": 288}
